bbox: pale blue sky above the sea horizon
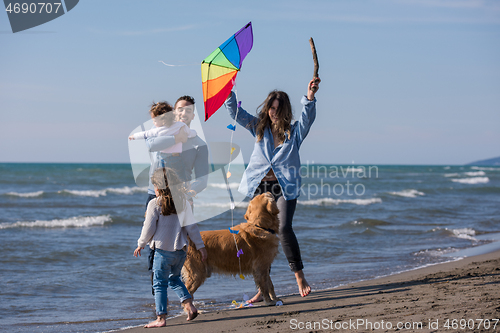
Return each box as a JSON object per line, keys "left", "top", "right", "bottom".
{"left": 0, "top": 0, "right": 500, "bottom": 164}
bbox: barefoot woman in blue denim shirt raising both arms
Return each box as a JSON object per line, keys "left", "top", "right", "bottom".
{"left": 225, "top": 79, "right": 320, "bottom": 303}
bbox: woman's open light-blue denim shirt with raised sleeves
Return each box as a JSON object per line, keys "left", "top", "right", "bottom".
{"left": 224, "top": 93, "right": 316, "bottom": 200}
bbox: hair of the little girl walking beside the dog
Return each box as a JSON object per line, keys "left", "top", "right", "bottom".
{"left": 151, "top": 168, "right": 186, "bottom": 216}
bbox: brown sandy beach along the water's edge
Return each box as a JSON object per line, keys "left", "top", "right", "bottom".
{"left": 121, "top": 251, "right": 500, "bottom": 333}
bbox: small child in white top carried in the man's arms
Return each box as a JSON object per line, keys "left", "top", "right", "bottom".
{"left": 128, "top": 102, "right": 196, "bottom": 154}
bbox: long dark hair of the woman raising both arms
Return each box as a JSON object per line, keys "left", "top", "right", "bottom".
{"left": 256, "top": 90, "right": 293, "bottom": 143}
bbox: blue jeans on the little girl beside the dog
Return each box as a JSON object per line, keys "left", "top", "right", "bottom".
{"left": 153, "top": 249, "right": 191, "bottom": 316}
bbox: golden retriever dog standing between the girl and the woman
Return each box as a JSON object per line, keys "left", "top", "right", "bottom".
{"left": 182, "top": 193, "right": 279, "bottom": 305}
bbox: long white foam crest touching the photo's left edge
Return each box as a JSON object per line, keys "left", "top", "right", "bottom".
{"left": 0, "top": 215, "right": 112, "bottom": 229}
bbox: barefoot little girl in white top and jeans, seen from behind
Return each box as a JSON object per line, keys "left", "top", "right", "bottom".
{"left": 134, "top": 168, "right": 207, "bottom": 328}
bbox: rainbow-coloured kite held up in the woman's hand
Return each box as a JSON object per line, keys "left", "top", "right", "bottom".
{"left": 201, "top": 22, "right": 253, "bottom": 121}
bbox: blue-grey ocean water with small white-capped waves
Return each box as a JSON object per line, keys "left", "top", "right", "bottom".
{"left": 0, "top": 163, "right": 500, "bottom": 332}
